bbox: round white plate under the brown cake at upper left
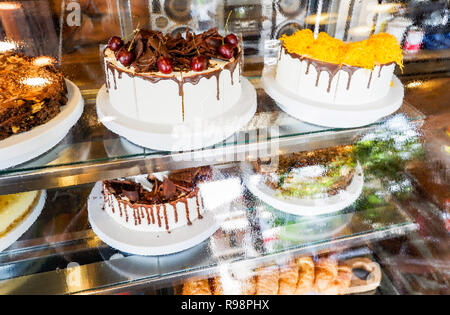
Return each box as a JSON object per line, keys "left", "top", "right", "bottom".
{"left": 0, "top": 79, "right": 84, "bottom": 169}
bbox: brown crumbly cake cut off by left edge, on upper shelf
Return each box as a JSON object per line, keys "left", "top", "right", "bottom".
{"left": 0, "top": 53, "right": 67, "bottom": 140}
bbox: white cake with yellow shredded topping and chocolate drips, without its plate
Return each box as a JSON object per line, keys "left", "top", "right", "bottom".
{"left": 276, "top": 29, "right": 403, "bottom": 105}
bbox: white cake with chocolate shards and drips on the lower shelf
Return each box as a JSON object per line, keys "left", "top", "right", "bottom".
{"left": 103, "top": 167, "right": 212, "bottom": 232}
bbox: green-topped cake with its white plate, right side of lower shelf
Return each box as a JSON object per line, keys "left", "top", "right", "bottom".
{"left": 243, "top": 145, "right": 364, "bottom": 216}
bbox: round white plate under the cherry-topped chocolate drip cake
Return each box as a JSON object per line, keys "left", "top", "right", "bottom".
{"left": 97, "top": 78, "right": 257, "bottom": 151}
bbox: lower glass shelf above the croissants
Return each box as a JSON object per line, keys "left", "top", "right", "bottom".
{"left": 0, "top": 163, "right": 417, "bottom": 294}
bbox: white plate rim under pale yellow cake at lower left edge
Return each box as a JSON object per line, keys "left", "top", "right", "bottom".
{"left": 0, "top": 190, "right": 47, "bottom": 252}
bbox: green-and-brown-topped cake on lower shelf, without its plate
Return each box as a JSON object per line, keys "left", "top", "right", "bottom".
{"left": 253, "top": 146, "right": 357, "bottom": 199}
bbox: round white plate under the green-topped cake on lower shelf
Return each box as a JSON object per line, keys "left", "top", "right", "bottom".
{"left": 243, "top": 163, "right": 364, "bottom": 216}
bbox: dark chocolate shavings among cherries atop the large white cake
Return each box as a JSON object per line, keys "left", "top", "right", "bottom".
{"left": 116, "top": 28, "right": 234, "bottom": 73}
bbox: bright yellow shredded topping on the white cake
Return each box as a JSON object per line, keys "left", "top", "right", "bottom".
{"left": 280, "top": 29, "right": 403, "bottom": 70}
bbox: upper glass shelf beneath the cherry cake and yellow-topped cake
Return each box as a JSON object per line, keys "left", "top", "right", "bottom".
{"left": 0, "top": 77, "right": 425, "bottom": 194}
